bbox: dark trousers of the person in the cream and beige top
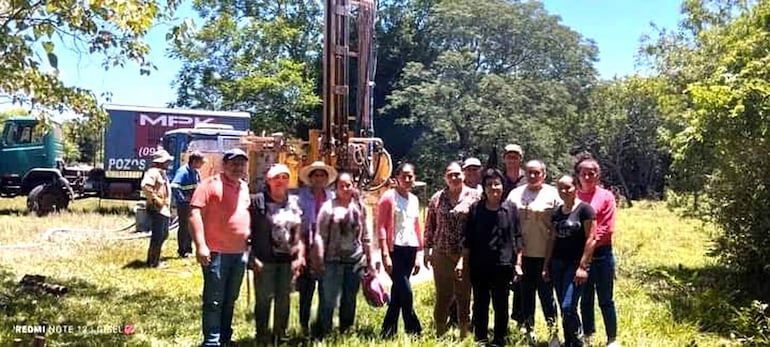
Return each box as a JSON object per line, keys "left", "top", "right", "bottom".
{"left": 519, "top": 257, "right": 556, "bottom": 329}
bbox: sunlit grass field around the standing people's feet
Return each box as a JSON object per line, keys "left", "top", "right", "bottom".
{"left": 0, "top": 199, "right": 739, "bottom": 347}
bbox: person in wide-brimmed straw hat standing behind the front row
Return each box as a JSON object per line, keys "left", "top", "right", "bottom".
{"left": 297, "top": 161, "right": 337, "bottom": 336}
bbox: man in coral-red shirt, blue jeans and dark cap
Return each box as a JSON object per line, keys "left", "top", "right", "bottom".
{"left": 190, "top": 148, "right": 251, "bottom": 346}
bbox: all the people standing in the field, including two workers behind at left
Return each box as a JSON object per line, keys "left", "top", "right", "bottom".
{"left": 136, "top": 145, "right": 617, "bottom": 346}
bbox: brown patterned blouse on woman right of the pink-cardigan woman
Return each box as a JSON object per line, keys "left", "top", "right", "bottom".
{"left": 425, "top": 185, "right": 481, "bottom": 254}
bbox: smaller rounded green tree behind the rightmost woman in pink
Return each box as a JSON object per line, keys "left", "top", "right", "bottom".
{"left": 563, "top": 77, "right": 669, "bottom": 203}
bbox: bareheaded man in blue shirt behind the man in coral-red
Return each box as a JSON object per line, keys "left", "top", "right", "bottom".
{"left": 171, "top": 151, "right": 206, "bottom": 258}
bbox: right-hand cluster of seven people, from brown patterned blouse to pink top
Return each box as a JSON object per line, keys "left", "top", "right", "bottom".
{"left": 424, "top": 144, "right": 618, "bottom": 346}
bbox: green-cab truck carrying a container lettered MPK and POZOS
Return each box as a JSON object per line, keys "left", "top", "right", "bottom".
{"left": 0, "top": 105, "right": 250, "bottom": 216}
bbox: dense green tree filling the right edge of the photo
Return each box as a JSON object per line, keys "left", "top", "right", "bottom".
{"left": 651, "top": 0, "right": 770, "bottom": 278}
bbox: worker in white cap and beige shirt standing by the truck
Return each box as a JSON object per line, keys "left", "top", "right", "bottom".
{"left": 141, "top": 149, "right": 174, "bottom": 267}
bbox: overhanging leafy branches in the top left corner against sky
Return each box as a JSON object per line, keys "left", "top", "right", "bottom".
{"left": 0, "top": 0, "right": 179, "bottom": 127}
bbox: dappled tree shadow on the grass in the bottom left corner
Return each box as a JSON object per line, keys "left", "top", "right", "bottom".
{"left": 0, "top": 267, "right": 199, "bottom": 346}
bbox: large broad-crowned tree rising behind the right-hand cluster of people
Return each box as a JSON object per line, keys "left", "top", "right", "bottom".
{"left": 388, "top": 0, "right": 596, "bottom": 188}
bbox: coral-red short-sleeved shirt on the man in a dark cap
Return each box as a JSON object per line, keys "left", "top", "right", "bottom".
{"left": 190, "top": 174, "right": 251, "bottom": 253}
